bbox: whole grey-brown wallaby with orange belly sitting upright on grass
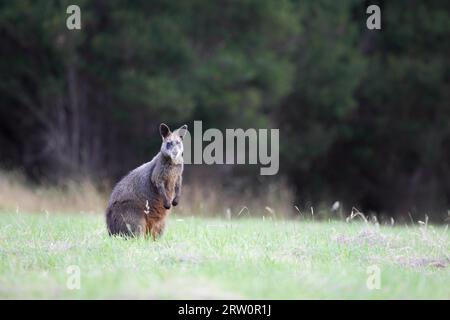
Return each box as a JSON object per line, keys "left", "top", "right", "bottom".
{"left": 106, "top": 123, "right": 187, "bottom": 239}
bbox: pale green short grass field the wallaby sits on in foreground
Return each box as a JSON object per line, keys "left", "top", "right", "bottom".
{"left": 0, "top": 214, "right": 450, "bottom": 299}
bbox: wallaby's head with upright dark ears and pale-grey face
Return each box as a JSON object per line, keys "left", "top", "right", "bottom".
{"left": 159, "top": 123, "right": 187, "bottom": 164}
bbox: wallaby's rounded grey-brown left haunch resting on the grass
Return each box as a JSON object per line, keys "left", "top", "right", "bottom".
{"left": 106, "top": 203, "right": 146, "bottom": 237}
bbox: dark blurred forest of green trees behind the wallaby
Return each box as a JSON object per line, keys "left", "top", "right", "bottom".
{"left": 0, "top": 0, "right": 450, "bottom": 221}
